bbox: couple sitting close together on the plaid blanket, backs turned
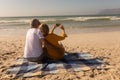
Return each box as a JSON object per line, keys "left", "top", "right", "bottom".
{"left": 24, "top": 19, "right": 67, "bottom": 62}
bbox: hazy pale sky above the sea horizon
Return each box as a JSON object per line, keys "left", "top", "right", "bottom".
{"left": 0, "top": 0, "right": 120, "bottom": 17}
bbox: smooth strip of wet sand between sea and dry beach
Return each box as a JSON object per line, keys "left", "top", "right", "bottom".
{"left": 0, "top": 26, "right": 120, "bottom": 36}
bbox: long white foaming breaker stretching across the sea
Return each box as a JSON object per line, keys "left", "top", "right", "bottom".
{"left": 0, "top": 16, "right": 120, "bottom": 24}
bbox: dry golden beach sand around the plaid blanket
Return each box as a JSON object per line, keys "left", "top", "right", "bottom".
{"left": 0, "top": 31, "right": 120, "bottom": 80}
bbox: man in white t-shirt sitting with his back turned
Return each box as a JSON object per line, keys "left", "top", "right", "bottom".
{"left": 24, "top": 19, "right": 44, "bottom": 62}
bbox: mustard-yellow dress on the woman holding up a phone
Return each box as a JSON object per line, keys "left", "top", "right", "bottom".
{"left": 45, "top": 33, "right": 65, "bottom": 60}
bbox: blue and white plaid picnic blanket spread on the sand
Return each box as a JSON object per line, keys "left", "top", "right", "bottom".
{"left": 7, "top": 53, "right": 104, "bottom": 78}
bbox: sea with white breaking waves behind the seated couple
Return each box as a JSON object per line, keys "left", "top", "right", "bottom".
{"left": 0, "top": 15, "right": 120, "bottom": 35}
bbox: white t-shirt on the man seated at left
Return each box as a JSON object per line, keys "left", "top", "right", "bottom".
{"left": 24, "top": 28, "right": 44, "bottom": 58}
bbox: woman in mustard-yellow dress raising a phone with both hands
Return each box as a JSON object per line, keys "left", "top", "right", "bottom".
{"left": 39, "top": 24, "right": 67, "bottom": 60}
